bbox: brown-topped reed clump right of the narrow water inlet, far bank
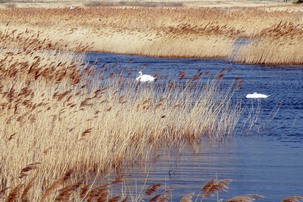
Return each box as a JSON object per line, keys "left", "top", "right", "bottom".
{"left": 235, "top": 21, "right": 303, "bottom": 65}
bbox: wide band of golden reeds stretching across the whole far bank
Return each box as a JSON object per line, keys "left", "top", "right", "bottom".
{"left": 0, "top": 4, "right": 303, "bottom": 64}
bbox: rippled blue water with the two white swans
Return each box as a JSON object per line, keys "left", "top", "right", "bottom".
{"left": 86, "top": 53, "right": 303, "bottom": 201}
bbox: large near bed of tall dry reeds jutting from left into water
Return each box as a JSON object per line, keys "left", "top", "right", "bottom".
{"left": 0, "top": 19, "right": 246, "bottom": 201}
